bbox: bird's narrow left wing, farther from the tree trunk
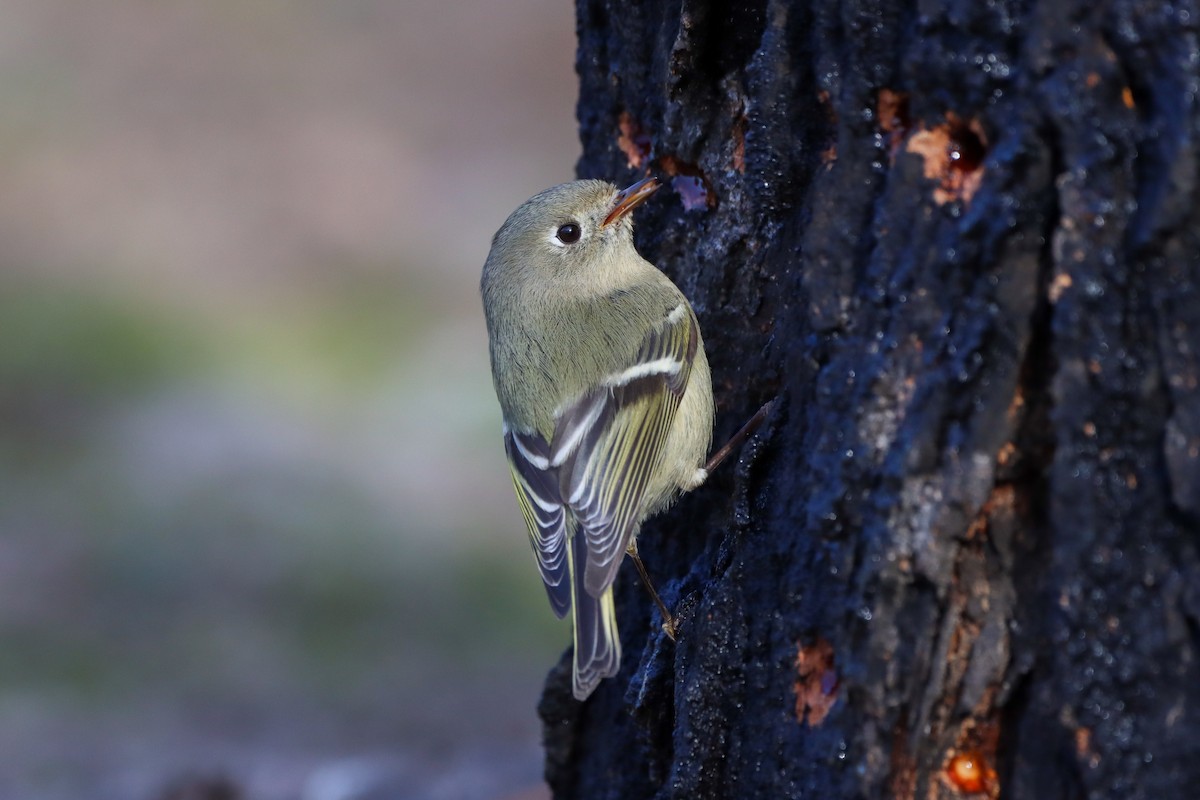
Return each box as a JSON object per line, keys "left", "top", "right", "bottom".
{"left": 504, "top": 426, "right": 571, "bottom": 619}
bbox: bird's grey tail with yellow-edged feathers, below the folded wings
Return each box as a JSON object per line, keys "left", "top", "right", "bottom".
{"left": 566, "top": 531, "right": 620, "bottom": 700}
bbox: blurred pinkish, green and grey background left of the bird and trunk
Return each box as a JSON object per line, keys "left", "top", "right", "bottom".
{"left": 0, "top": 0, "right": 578, "bottom": 800}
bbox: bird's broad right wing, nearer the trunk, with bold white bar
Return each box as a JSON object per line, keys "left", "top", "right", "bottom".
{"left": 548, "top": 303, "right": 700, "bottom": 597}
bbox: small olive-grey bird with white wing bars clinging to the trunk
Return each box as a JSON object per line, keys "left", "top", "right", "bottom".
{"left": 480, "top": 179, "right": 728, "bottom": 700}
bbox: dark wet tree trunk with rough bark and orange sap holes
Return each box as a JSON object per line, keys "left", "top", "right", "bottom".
{"left": 541, "top": 0, "right": 1200, "bottom": 800}
